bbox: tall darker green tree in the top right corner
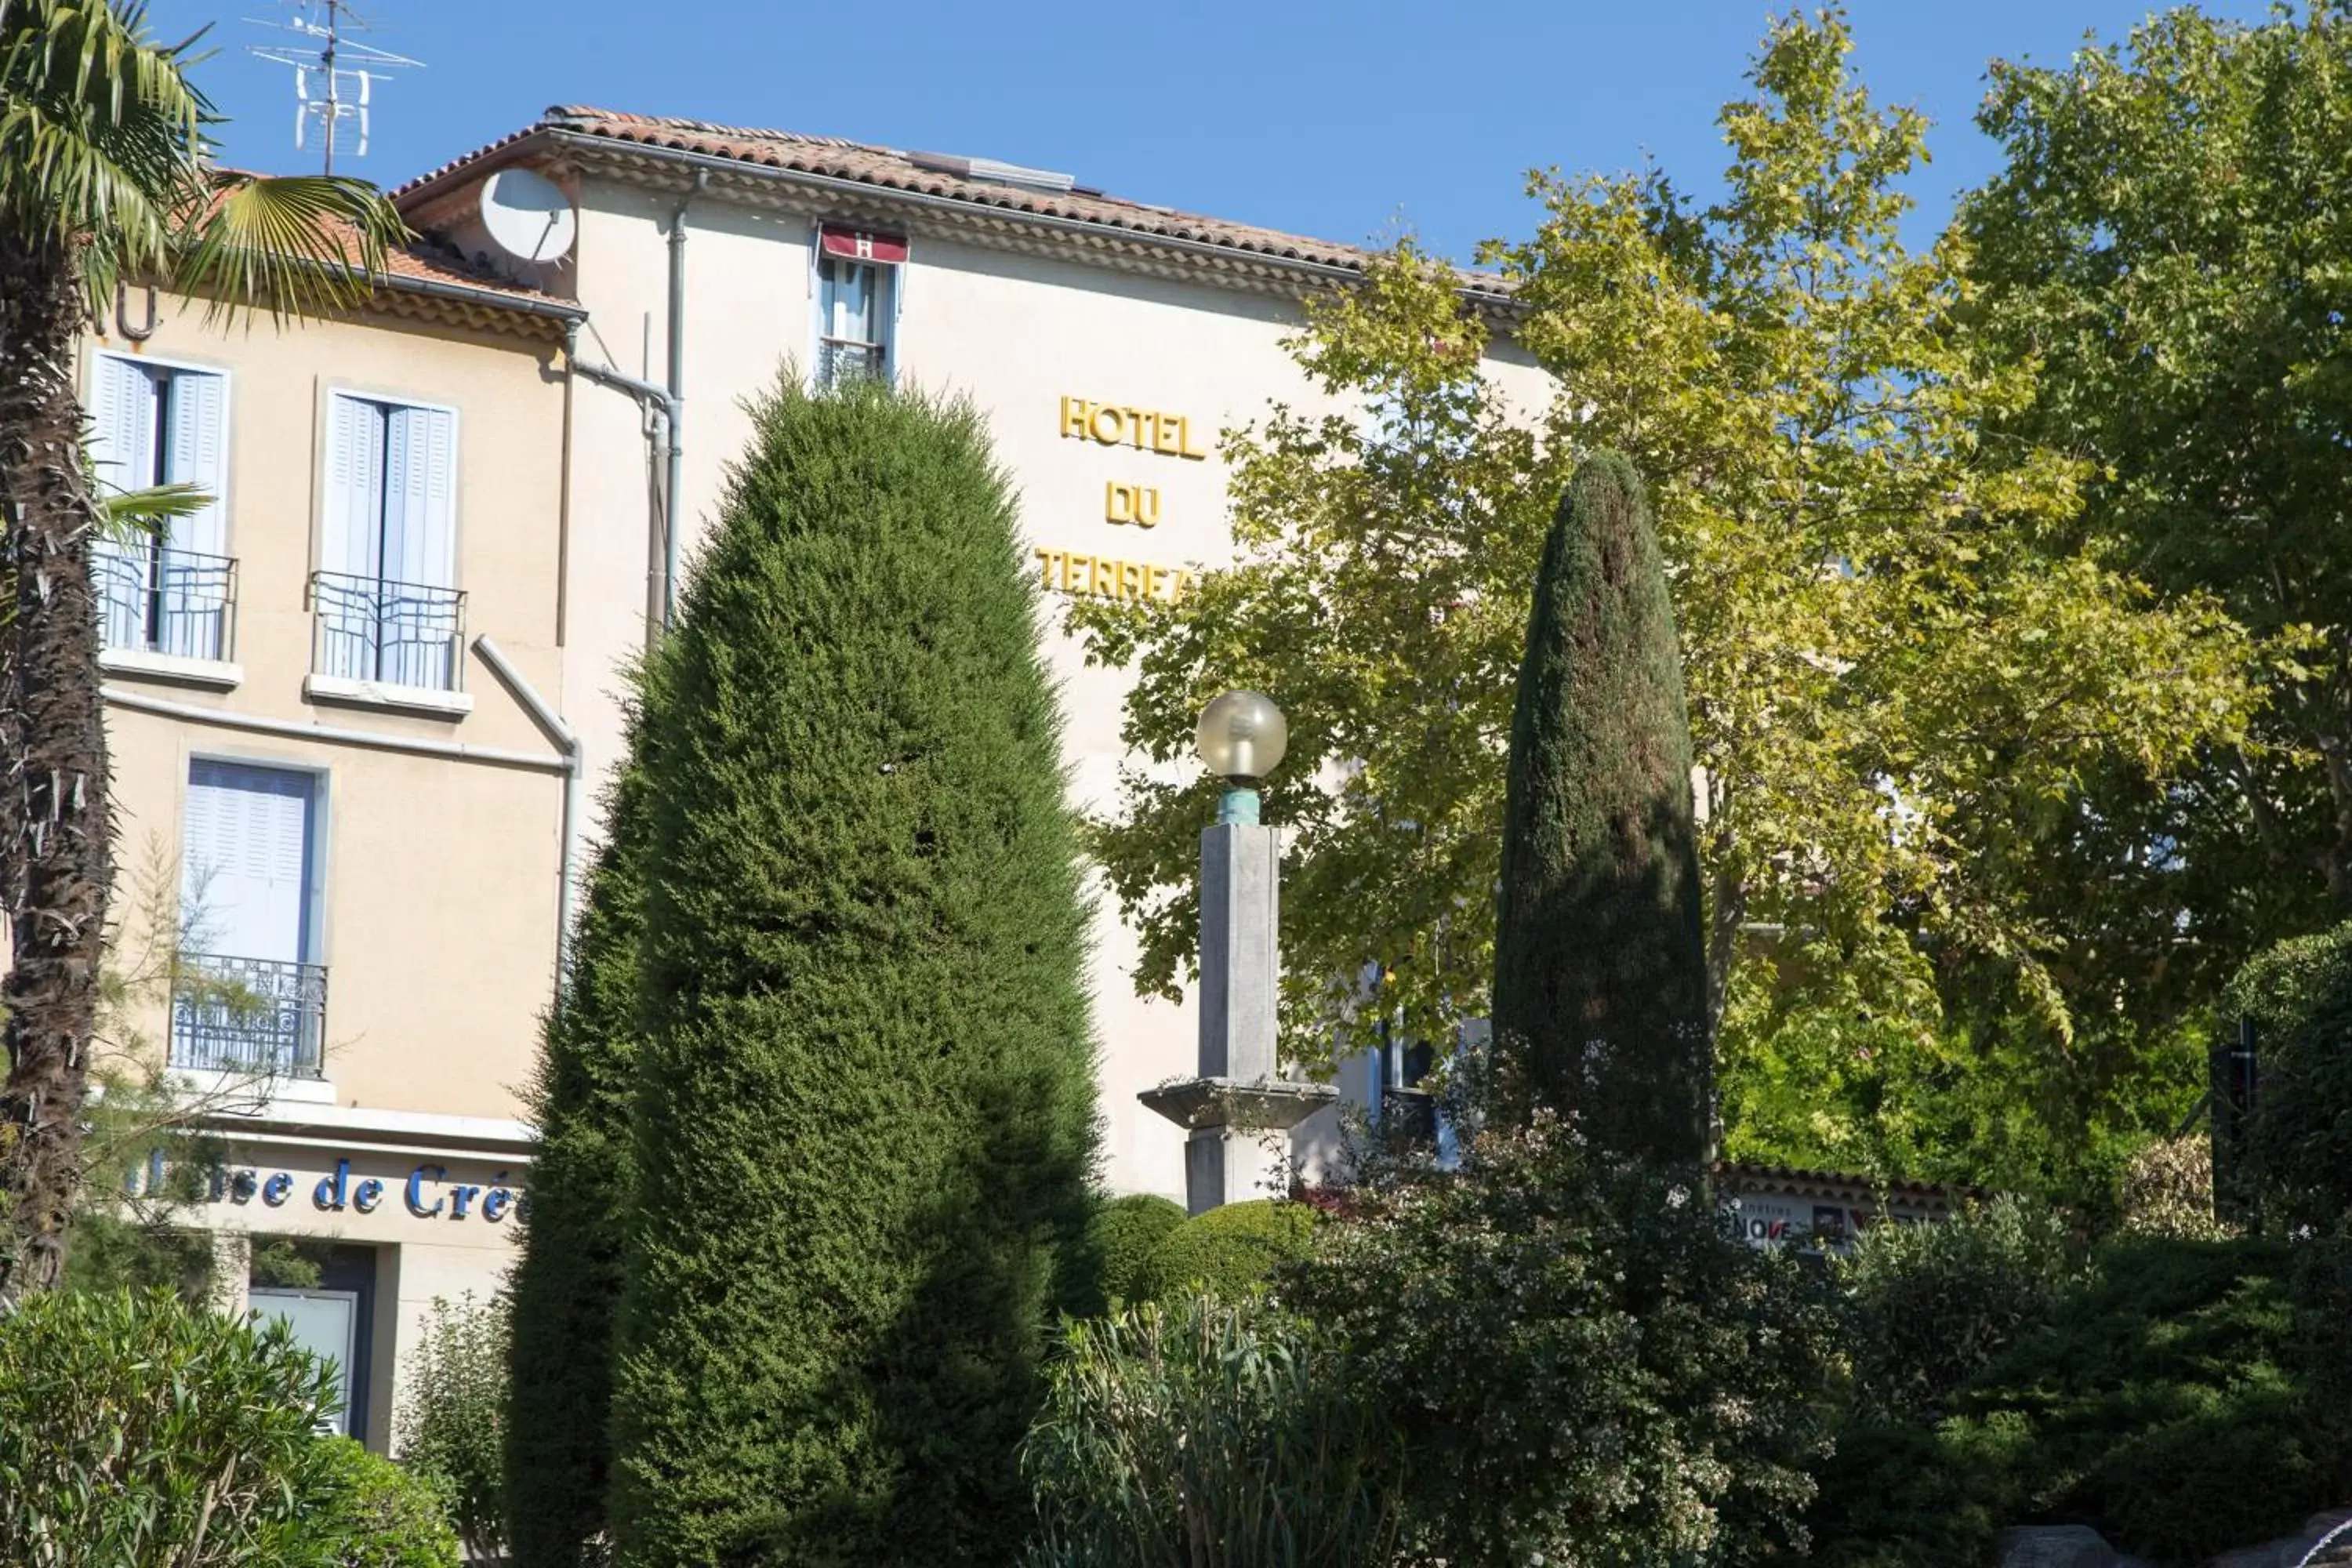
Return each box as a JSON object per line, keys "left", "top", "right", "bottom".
{"left": 1957, "top": 5, "right": 2352, "bottom": 973}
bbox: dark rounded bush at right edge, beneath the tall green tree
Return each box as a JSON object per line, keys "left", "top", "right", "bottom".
{"left": 2227, "top": 921, "right": 2352, "bottom": 1229}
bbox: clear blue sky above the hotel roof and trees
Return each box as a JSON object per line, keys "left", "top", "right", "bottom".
{"left": 153, "top": 0, "right": 2265, "bottom": 259}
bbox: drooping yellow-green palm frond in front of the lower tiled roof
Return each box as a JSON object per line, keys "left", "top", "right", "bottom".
{"left": 172, "top": 169, "right": 409, "bottom": 322}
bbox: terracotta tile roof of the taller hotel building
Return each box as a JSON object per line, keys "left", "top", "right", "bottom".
{"left": 393, "top": 106, "right": 1510, "bottom": 296}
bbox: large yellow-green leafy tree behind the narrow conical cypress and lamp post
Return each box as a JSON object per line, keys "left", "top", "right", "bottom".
{"left": 1073, "top": 12, "right": 2249, "bottom": 1185}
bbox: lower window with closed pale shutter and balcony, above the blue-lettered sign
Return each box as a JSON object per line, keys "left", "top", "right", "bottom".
{"left": 172, "top": 757, "right": 327, "bottom": 1079}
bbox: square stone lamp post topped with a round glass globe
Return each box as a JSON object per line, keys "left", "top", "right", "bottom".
{"left": 1138, "top": 691, "right": 1338, "bottom": 1213}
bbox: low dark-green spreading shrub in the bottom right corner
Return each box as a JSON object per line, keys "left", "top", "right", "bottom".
{"left": 1809, "top": 1241, "right": 2352, "bottom": 1568}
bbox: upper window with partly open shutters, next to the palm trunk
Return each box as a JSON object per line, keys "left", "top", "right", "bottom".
{"left": 89, "top": 353, "right": 238, "bottom": 661}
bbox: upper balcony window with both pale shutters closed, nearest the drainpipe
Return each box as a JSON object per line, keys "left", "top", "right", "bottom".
{"left": 310, "top": 393, "right": 466, "bottom": 691}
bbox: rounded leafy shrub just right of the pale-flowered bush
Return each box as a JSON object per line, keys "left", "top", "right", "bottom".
{"left": 1835, "top": 1196, "right": 2082, "bottom": 1413}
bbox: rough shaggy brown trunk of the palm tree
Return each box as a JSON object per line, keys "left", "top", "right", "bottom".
{"left": 0, "top": 233, "right": 113, "bottom": 1307}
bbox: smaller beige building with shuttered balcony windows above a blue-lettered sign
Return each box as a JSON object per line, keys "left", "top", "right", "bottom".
{"left": 82, "top": 252, "right": 583, "bottom": 1448}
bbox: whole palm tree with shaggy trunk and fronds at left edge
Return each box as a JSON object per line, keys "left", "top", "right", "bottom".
{"left": 0, "top": 0, "right": 407, "bottom": 1307}
